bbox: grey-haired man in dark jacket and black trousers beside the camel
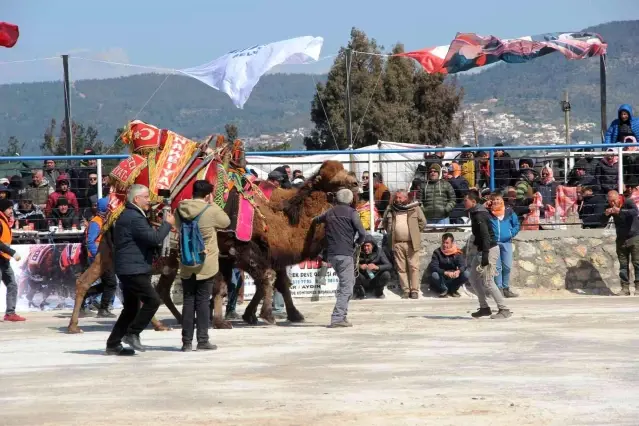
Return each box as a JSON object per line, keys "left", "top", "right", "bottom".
{"left": 106, "top": 184, "right": 175, "bottom": 355}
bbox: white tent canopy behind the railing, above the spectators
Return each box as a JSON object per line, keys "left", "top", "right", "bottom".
{"left": 246, "top": 141, "right": 459, "bottom": 191}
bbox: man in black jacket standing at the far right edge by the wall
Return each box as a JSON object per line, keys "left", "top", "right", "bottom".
{"left": 605, "top": 190, "right": 639, "bottom": 296}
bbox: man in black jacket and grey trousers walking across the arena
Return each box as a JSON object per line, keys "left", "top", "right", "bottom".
{"left": 464, "top": 190, "right": 512, "bottom": 319}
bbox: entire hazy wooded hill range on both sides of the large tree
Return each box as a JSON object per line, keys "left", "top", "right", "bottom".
{"left": 0, "top": 21, "right": 639, "bottom": 154}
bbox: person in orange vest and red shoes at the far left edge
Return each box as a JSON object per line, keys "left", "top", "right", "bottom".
{"left": 0, "top": 198, "right": 25, "bottom": 322}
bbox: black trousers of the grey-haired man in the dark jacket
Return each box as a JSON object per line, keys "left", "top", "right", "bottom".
{"left": 107, "top": 274, "right": 162, "bottom": 348}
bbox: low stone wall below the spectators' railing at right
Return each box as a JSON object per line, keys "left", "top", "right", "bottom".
{"left": 421, "top": 227, "right": 619, "bottom": 294}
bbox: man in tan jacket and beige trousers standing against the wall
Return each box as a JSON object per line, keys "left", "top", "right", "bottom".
{"left": 382, "top": 191, "right": 426, "bottom": 299}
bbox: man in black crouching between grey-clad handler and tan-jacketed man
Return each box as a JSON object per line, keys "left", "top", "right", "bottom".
{"left": 353, "top": 234, "right": 393, "bottom": 299}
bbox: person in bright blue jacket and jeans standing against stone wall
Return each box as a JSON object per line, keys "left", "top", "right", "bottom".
{"left": 487, "top": 194, "right": 519, "bottom": 297}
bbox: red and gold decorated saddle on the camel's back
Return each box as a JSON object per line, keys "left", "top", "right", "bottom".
{"left": 102, "top": 120, "right": 272, "bottom": 241}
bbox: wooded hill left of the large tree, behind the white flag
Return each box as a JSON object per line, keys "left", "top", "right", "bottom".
{"left": 0, "top": 74, "right": 326, "bottom": 154}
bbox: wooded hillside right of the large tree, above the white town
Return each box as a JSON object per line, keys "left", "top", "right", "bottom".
{"left": 458, "top": 21, "right": 639, "bottom": 140}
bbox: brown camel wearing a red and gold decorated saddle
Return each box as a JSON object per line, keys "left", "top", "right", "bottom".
{"left": 68, "top": 121, "right": 357, "bottom": 333}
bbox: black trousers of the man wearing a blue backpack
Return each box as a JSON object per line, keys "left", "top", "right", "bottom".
{"left": 182, "top": 275, "right": 213, "bottom": 343}
